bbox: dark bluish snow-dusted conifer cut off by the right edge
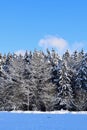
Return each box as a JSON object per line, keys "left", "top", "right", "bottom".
{"left": 74, "top": 55, "right": 87, "bottom": 110}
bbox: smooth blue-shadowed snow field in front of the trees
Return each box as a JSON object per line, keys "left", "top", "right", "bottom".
{"left": 0, "top": 112, "right": 87, "bottom": 130}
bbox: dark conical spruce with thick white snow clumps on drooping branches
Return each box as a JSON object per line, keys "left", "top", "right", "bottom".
{"left": 58, "top": 62, "right": 73, "bottom": 109}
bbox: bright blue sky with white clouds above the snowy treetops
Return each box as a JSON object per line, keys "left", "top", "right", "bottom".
{"left": 0, "top": 0, "right": 87, "bottom": 53}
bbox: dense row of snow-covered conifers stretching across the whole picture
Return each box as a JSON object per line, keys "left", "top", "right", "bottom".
{"left": 0, "top": 49, "right": 87, "bottom": 111}
